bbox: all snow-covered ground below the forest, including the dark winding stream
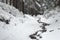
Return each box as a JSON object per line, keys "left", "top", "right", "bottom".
{"left": 0, "top": 3, "right": 60, "bottom": 40}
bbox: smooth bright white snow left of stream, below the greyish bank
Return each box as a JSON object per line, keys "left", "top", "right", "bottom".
{"left": 0, "top": 13, "right": 40, "bottom": 40}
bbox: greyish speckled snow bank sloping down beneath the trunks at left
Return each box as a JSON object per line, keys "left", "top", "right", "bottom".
{"left": 0, "top": 2, "right": 23, "bottom": 17}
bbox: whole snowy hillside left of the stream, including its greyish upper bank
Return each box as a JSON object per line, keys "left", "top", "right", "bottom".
{"left": 0, "top": 3, "right": 40, "bottom": 40}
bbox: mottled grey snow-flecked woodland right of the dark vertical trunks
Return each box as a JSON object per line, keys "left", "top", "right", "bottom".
{"left": 24, "top": 0, "right": 60, "bottom": 15}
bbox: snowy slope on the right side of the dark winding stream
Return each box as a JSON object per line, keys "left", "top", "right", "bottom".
{"left": 37, "top": 7, "right": 60, "bottom": 40}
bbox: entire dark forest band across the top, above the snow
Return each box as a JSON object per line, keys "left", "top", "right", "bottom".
{"left": 1, "top": 0, "right": 60, "bottom": 15}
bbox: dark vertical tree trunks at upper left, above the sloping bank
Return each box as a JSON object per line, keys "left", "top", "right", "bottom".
{"left": 1, "top": 0, "right": 24, "bottom": 11}
